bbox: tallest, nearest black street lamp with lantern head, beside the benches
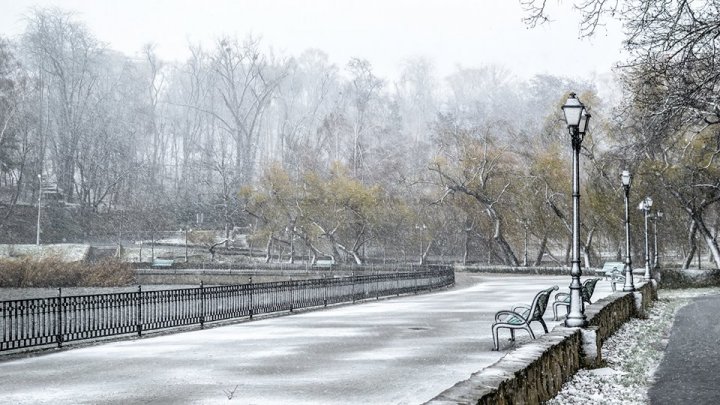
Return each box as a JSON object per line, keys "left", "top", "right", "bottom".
{"left": 562, "top": 93, "right": 590, "bottom": 327}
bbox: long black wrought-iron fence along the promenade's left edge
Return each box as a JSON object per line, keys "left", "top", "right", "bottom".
{"left": 0, "top": 266, "right": 455, "bottom": 351}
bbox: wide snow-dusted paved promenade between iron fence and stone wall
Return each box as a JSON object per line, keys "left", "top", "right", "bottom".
{"left": 0, "top": 274, "right": 611, "bottom": 404}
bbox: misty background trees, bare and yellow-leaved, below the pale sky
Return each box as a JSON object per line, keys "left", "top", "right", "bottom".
{"left": 0, "top": 6, "right": 720, "bottom": 266}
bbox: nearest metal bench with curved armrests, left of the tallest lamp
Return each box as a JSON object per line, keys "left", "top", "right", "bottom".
{"left": 492, "top": 285, "right": 558, "bottom": 350}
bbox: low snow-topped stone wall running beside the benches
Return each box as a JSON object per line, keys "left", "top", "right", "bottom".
{"left": 428, "top": 283, "right": 657, "bottom": 405}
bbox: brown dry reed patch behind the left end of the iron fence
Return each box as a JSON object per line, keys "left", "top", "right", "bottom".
{"left": 0, "top": 258, "right": 135, "bottom": 288}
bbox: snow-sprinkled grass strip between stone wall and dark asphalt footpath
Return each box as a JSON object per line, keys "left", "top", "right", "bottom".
{"left": 548, "top": 288, "right": 720, "bottom": 405}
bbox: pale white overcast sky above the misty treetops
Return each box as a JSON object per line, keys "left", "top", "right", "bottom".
{"left": 0, "top": 0, "right": 622, "bottom": 79}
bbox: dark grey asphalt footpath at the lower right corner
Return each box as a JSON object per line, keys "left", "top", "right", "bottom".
{"left": 648, "top": 295, "right": 720, "bottom": 405}
